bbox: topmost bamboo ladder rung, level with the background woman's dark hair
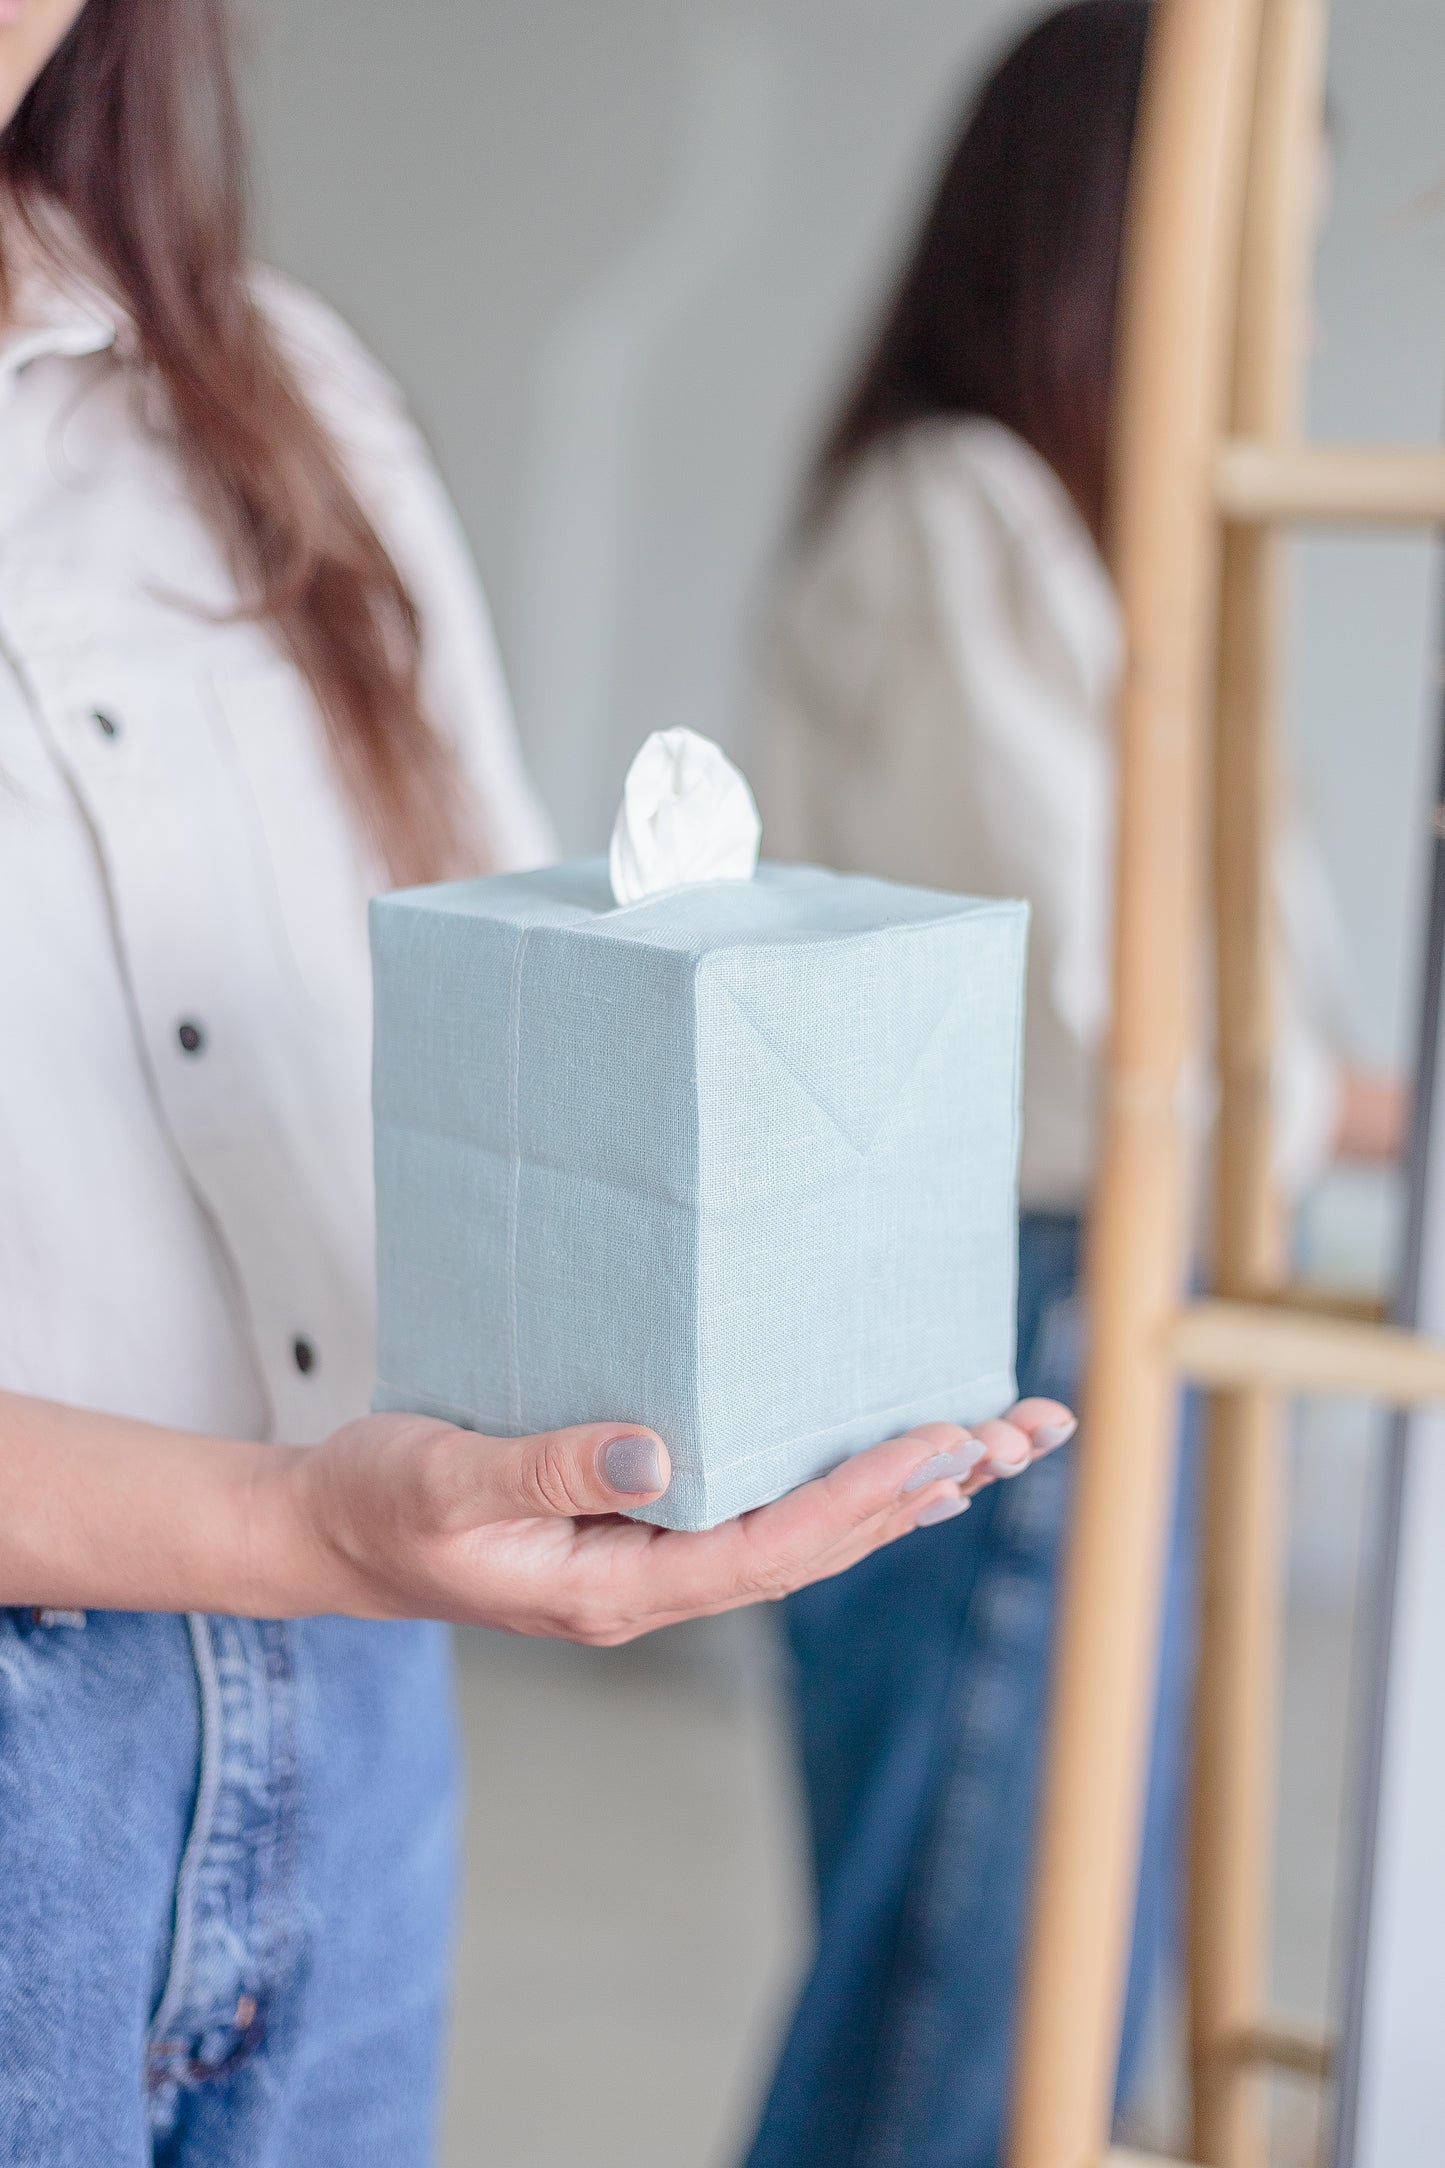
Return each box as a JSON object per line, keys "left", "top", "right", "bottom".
{"left": 1213, "top": 436, "right": 1445, "bottom": 527}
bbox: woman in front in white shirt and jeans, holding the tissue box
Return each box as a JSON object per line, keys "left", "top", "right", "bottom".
{"left": 0, "top": 0, "right": 1066, "bottom": 2168}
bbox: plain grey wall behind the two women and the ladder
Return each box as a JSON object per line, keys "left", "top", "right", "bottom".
{"left": 251, "top": 0, "right": 1445, "bottom": 1056}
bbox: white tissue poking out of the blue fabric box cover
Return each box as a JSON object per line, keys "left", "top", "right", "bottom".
{"left": 607, "top": 731, "right": 763, "bottom": 904}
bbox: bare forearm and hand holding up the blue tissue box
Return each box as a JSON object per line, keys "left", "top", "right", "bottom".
{"left": 0, "top": 1394, "right": 1075, "bottom": 1641}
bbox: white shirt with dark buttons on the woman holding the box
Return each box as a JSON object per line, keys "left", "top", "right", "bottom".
{"left": 0, "top": 228, "right": 550, "bottom": 1442}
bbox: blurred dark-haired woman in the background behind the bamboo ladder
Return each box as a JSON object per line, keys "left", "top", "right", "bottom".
{"left": 750, "top": 0, "right": 1397, "bottom": 2168}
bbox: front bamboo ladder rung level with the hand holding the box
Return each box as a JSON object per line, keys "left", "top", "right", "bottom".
{"left": 1166, "top": 1301, "right": 1445, "bottom": 1407}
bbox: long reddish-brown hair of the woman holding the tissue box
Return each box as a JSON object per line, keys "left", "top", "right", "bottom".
{"left": 0, "top": 0, "right": 474, "bottom": 880}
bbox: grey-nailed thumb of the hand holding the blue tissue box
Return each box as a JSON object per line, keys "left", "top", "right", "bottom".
{"left": 411, "top": 1422, "right": 672, "bottom": 1533}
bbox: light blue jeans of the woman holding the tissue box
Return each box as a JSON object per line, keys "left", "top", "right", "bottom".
{"left": 0, "top": 1611, "right": 457, "bottom": 2168}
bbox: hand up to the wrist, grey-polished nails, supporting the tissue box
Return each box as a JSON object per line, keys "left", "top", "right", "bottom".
{"left": 279, "top": 1401, "right": 1075, "bottom": 1643}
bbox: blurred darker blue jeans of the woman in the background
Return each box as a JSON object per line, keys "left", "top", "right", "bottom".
{"left": 750, "top": 1214, "right": 1196, "bottom": 2168}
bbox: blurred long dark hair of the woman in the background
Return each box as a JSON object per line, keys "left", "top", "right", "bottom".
{"left": 808, "top": 0, "right": 1150, "bottom": 535}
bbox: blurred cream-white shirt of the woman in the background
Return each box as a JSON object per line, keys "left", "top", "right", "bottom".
{"left": 750, "top": 421, "right": 1343, "bottom": 1210}
